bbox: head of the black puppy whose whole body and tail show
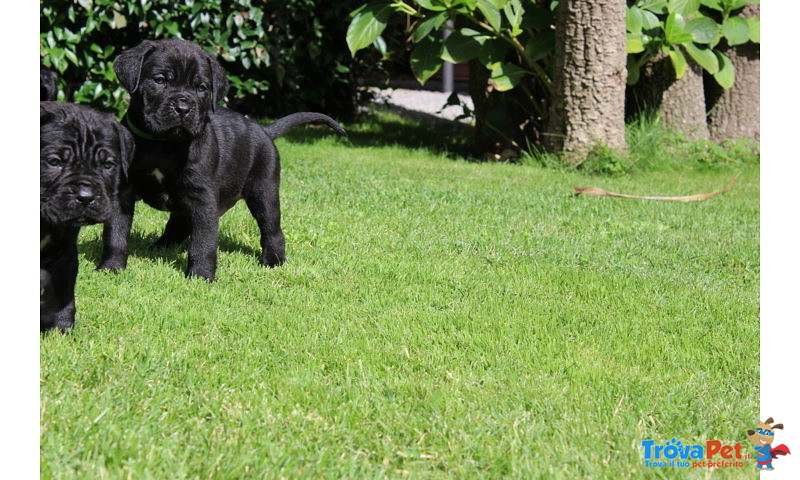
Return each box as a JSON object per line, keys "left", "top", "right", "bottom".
{"left": 114, "top": 39, "right": 228, "bottom": 139}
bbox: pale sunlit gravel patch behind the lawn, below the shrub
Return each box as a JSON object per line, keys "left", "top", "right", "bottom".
{"left": 370, "top": 87, "right": 472, "bottom": 124}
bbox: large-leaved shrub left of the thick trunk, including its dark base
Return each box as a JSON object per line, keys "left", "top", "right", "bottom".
{"left": 347, "top": 0, "right": 557, "bottom": 151}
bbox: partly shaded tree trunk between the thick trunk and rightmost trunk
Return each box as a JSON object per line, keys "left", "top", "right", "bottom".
{"left": 628, "top": 53, "right": 709, "bottom": 140}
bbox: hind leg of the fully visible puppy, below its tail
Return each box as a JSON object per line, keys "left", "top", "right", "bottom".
{"left": 244, "top": 170, "right": 286, "bottom": 267}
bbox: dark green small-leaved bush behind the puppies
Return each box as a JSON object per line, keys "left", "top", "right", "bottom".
{"left": 40, "top": 0, "right": 380, "bottom": 117}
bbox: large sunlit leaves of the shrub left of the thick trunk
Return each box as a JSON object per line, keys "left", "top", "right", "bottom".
{"left": 347, "top": 0, "right": 553, "bottom": 91}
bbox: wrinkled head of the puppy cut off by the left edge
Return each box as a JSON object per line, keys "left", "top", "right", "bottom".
{"left": 39, "top": 102, "right": 134, "bottom": 226}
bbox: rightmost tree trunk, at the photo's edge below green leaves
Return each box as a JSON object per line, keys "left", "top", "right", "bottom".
{"left": 707, "top": 4, "right": 761, "bottom": 142}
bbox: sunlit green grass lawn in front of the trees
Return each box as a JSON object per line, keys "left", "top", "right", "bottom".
{"left": 41, "top": 115, "right": 759, "bottom": 480}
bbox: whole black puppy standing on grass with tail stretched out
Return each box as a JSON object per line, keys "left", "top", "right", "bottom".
{"left": 99, "top": 39, "right": 345, "bottom": 281}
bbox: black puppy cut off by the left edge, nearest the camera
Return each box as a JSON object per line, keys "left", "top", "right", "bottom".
{"left": 39, "top": 102, "right": 134, "bottom": 331}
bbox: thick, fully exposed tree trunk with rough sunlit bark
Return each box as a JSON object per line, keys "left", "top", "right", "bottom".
{"left": 545, "top": 0, "right": 627, "bottom": 162}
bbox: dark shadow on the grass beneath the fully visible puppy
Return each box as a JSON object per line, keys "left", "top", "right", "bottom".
{"left": 78, "top": 231, "right": 261, "bottom": 272}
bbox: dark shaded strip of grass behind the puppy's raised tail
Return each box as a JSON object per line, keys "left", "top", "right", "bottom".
{"left": 261, "top": 107, "right": 476, "bottom": 160}
